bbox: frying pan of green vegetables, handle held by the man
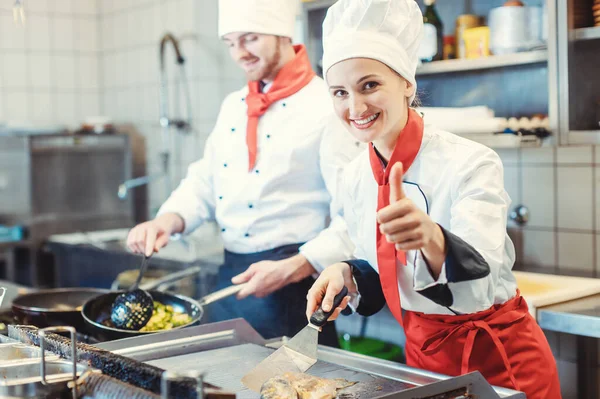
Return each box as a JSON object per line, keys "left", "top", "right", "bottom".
{"left": 81, "top": 284, "right": 246, "bottom": 341}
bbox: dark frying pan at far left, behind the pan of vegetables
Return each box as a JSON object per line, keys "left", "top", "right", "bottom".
{"left": 12, "top": 267, "right": 200, "bottom": 333}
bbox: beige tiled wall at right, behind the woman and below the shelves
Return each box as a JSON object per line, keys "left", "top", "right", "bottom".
{"left": 500, "top": 146, "right": 600, "bottom": 399}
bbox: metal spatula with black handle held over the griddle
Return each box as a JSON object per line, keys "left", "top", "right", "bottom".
{"left": 242, "top": 287, "right": 348, "bottom": 392}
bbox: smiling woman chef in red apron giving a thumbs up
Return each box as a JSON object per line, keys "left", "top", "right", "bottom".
{"left": 307, "top": 0, "right": 560, "bottom": 399}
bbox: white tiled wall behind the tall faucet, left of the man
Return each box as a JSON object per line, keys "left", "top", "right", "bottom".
{"left": 99, "top": 0, "right": 244, "bottom": 211}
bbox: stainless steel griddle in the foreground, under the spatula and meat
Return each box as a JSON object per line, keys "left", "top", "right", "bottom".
{"left": 96, "top": 319, "right": 525, "bottom": 399}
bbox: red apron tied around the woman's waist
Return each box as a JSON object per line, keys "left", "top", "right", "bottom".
{"left": 404, "top": 293, "right": 561, "bottom": 399}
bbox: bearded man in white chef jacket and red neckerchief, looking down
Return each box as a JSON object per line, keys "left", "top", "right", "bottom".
{"left": 128, "top": 0, "right": 361, "bottom": 346}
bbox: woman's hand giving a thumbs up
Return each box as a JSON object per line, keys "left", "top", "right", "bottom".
{"left": 377, "top": 162, "right": 443, "bottom": 251}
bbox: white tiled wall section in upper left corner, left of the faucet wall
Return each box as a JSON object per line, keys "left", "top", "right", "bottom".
{"left": 0, "top": 0, "right": 100, "bottom": 127}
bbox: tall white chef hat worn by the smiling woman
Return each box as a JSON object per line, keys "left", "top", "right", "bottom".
{"left": 323, "top": 0, "right": 423, "bottom": 103}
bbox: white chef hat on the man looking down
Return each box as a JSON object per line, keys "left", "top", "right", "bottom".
{"left": 219, "top": 0, "right": 298, "bottom": 38}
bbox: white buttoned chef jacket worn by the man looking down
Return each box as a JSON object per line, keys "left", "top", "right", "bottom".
{"left": 159, "top": 77, "right": 365, "bottom": 270}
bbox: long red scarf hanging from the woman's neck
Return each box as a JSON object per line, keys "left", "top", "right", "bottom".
{"left": 369, "top": 109, "right": 423, "bottom": 325}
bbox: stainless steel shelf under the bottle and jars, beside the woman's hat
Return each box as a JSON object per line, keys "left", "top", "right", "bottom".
{"left": 417, "top": 50, "right": 548, "bottom": 76}
